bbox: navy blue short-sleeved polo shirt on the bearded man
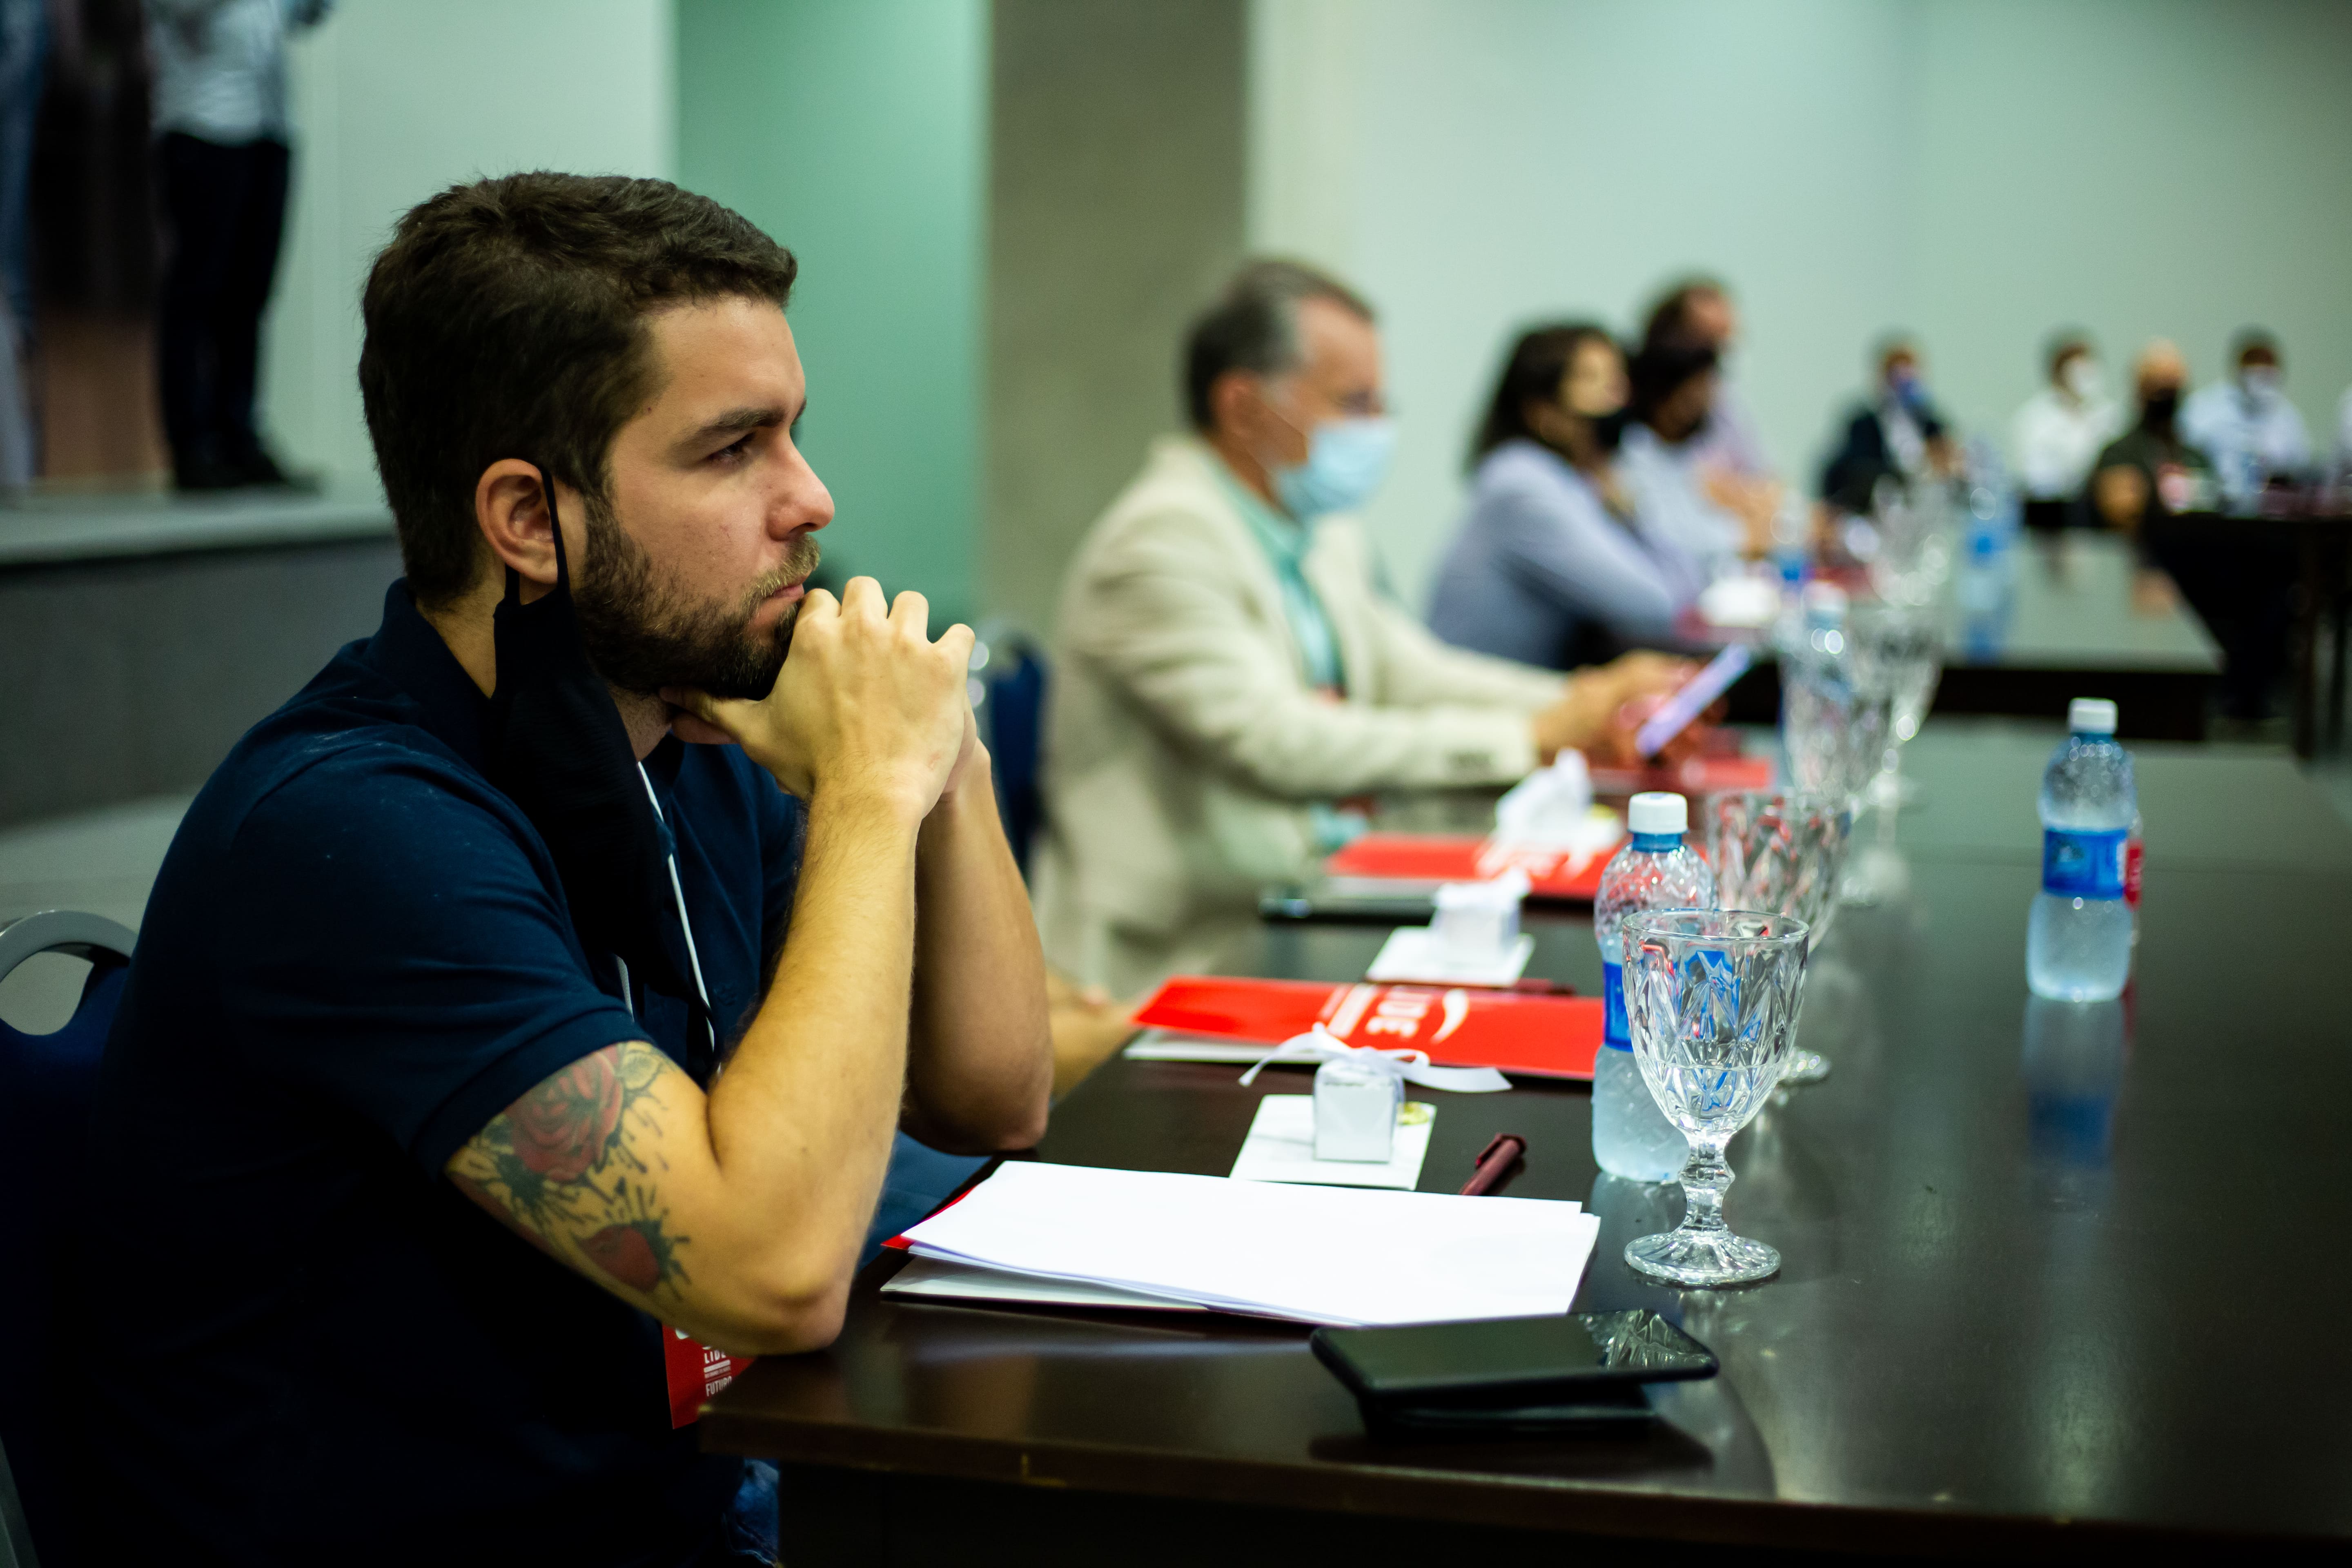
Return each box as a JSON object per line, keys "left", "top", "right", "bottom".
{"left": 73, "top": 583, "right": 804, "bottom": 1568}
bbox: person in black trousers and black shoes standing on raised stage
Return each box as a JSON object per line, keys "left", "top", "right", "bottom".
{"left": 146, "top": 0, "right": 334, "bottom": 491}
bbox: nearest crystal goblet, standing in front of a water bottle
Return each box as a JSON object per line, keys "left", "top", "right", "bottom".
{"left": 1623, "top": 910, "right": 1809, "bottom": 1286}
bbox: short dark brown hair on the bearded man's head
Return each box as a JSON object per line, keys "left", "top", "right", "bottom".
{"left": 360, "top": 174, "right": 800, "bottom": 606}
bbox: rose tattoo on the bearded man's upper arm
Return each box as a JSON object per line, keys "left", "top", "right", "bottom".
{"left": 447, "top": 1041, "right": 689, "bottom": 1295}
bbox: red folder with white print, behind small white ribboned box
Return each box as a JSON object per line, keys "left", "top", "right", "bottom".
{"left": 1136, "top": 976, "right": 1602, "bottom": 1079}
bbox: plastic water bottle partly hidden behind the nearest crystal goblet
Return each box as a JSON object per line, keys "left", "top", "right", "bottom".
{"left": 1592, "top": 795, "right": 1715, "bottom": 1183}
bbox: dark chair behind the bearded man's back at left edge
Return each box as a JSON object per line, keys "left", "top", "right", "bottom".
{"left": 0, "top": 910, "right": 134, "bottom": 1568}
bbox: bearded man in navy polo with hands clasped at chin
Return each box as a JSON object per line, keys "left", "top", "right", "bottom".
{"left": 78, "top": 174, "right": 1051, "bottom": 1566}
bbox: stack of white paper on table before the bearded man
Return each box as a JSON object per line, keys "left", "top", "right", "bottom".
{"left": 906, "top": 1161, "right": 1599, "bottom": 1326}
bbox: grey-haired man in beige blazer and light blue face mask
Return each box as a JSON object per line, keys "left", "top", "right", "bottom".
{"left": 1037, "top": 261, "right": 1689, "bottom": 994}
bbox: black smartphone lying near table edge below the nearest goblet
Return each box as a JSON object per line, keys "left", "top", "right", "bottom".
{"left": 1308, "top": 1307, "right": 1719, "bottom": 1410}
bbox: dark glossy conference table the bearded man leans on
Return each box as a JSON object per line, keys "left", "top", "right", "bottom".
{"left": 703, "top": 719, "right": 2352, "bottom": 1566}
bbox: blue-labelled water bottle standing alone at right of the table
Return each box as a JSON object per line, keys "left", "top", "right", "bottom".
{"left": 2025, "top": 696, "right": 2138, "bottom": 1002}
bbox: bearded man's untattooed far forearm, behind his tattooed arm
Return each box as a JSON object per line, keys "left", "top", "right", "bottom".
{"left": 906, "top": 750, "right": 1054, "bottom": 1154}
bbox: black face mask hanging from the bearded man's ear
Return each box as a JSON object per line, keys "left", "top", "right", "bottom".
{"left": 487, "top": 468, "right": 703, "bottom": 1044}
